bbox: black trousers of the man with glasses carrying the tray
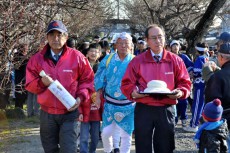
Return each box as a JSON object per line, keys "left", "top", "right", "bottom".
{"left": 134, "top": 103, "right": 175, "bottom": 153}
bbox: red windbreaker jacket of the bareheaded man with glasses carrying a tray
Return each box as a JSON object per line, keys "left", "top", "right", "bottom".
{"left": 121, "top": 49, "right": 191, "bottom": 106}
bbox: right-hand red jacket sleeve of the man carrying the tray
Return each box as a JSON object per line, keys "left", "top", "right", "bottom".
{"left": 175, "top": 57, "right": 192, "bottom": 99}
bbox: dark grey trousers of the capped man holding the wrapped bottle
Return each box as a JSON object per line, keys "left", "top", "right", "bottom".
{"left": 40, "top": 110, "right": 77, "bottom": 153}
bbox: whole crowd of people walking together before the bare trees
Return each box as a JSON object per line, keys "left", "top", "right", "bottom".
{"left": 3, "top": 20, "right": 230, "bottom": 153}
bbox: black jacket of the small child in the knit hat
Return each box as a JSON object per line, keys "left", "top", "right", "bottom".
{"left": 199, "top": 120, "right": 228, "bottom": 153}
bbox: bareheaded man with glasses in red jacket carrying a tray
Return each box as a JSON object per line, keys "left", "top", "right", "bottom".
{"left": 121, "top": 24, "right": 191, "bottom": 153}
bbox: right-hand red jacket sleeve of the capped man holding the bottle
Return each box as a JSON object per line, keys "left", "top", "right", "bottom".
{"left": 76, "top": 57, "right": 94, "bottom": 102}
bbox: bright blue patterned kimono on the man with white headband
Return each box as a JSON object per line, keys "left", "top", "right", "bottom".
{"left": 94, "top": 53, "right": 135, "bottom": 135}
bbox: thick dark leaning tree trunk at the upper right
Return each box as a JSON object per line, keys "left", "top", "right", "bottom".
{"left": 183, "top": 0, "right": 227, "bottom": 54}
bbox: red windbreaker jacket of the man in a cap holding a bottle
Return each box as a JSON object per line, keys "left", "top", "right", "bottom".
{"left": 26, "top": 44, "right": 94, "bottom": 114}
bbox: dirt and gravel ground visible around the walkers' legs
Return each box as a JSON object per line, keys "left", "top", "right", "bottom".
{"left": 0, "top": 118, "right": 197, "bottom": 153}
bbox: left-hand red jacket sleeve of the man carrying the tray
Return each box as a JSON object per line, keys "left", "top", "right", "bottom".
{"left": 121, "top": 60, "right": 137, "bottom": 100}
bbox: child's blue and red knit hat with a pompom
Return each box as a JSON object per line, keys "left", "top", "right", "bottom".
{"left": 202, "top": 99, "right": 223, "bottom": 122}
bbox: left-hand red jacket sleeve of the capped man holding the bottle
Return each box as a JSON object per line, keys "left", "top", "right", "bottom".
{"left": 25, "top": 55, "right": 47, "bottom": 94}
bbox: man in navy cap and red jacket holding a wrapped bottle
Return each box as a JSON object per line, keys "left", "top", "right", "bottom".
{"left": 26, "top": 21, "right": 94, "bottom": 153}
